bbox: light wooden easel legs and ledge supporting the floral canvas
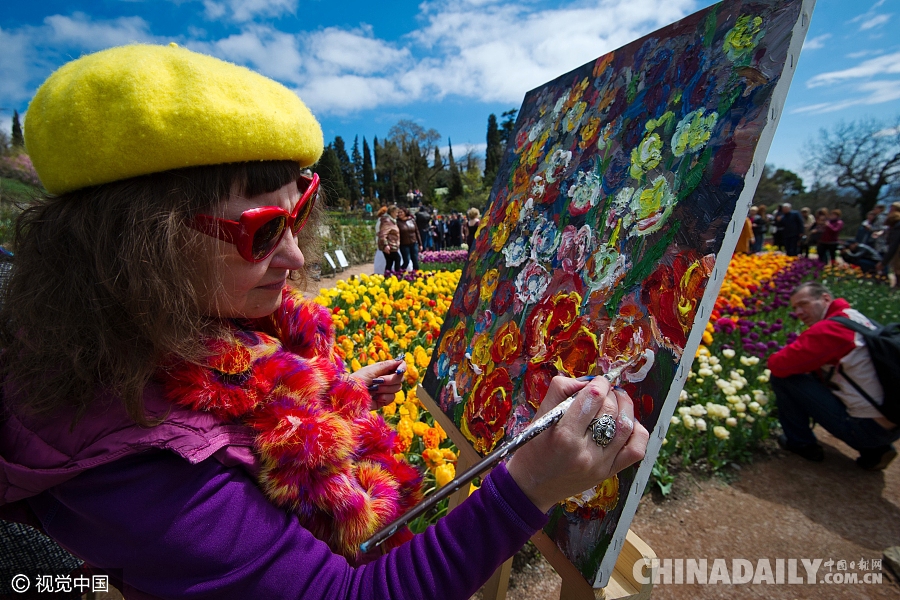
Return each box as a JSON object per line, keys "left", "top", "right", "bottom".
{"left": 416, "top": 385, "right": 656, "bottom": 600}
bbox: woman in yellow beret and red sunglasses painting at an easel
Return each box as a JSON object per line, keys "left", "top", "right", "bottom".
{"left": 0, "top": 45, "right": 648, "bottom": 600}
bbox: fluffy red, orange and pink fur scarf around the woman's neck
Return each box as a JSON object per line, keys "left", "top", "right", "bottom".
{"left": 162, "top": 288, "right": 422, "bottom": 561}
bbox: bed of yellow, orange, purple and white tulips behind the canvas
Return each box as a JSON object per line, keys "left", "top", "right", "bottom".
{"left": 317, "top": 253, "right": 900, "bottom": 506}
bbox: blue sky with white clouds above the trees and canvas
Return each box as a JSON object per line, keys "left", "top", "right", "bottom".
{"left": 0, "top": 0, "right": 900, "bottom": 182}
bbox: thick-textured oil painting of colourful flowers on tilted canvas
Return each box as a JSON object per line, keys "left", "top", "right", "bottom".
{"left": 423, "top": 0, "right": 814, "bottom": 587}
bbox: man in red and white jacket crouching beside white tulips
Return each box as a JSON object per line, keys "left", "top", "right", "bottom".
{"left": 769, "top": 282, "right": 900, "bottom": 471}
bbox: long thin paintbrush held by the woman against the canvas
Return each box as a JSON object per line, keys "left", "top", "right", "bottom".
{"left": 359, "top": 365, "right": 624, "bottom": 554}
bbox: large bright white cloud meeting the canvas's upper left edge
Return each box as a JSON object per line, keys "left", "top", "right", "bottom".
{"left": 404, "top": 0, "right": 696, "bottom": 102}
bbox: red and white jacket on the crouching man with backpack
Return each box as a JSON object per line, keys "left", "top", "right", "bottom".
{"left": 769, "top": 298, "right": 890, "bottom": 424}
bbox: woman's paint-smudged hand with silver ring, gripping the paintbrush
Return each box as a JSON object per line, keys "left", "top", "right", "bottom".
{"left": 507, "top": 377, "right": 650, "bottom": 512}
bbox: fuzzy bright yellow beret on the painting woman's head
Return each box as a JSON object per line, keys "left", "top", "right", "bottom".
{"left": 24, "top": 44, "right": 323, "bottom": 194}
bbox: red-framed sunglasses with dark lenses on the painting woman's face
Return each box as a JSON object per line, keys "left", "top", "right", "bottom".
{"left": 190, "top": 173, "right": 319, "bottom": 262}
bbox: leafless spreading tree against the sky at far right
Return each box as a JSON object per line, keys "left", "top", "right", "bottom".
{"left": 807, "top": 117, "right": 900, "bottom": 216}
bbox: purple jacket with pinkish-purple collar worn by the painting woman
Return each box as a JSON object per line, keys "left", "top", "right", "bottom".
{"left": 0, "top": 385, "right": 547, "bottom": 600}
